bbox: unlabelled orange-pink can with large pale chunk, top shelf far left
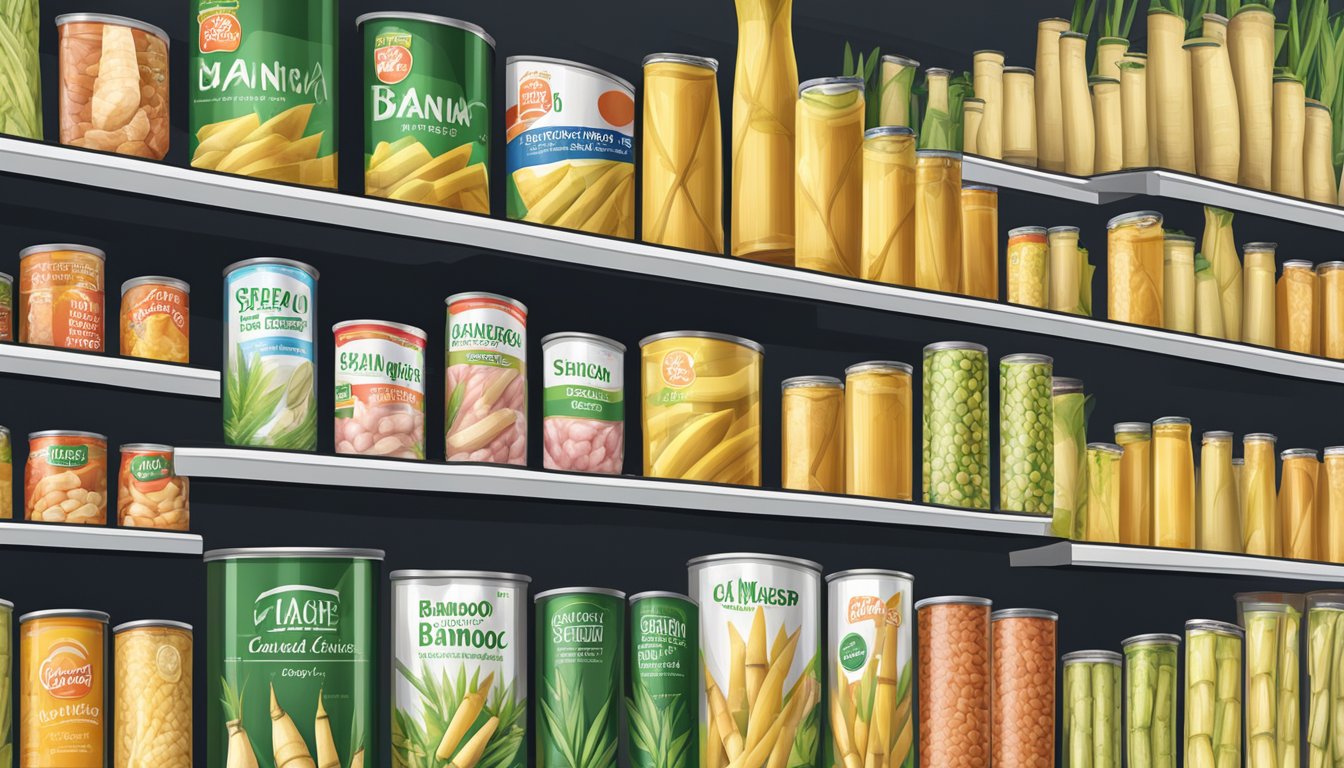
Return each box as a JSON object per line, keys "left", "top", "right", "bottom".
{"left": 56, "top": 13, "right": 168, "bottom": 160}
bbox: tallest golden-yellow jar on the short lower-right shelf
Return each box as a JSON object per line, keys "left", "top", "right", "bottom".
{"left": 1153, "top": 416, "right": 1195, "bottom": 549}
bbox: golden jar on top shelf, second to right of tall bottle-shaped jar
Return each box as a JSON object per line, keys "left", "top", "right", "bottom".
{"left": 859, "top": 125, "right": 915, "bottom": 285}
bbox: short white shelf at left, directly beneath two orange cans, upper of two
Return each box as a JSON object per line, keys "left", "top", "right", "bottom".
{"left": 0, "top": 344, "right": 219, "bottom": 399}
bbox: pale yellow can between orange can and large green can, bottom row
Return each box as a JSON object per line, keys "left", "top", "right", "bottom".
{"left": 112, "top": 620, "right": 194, "bottom": 768}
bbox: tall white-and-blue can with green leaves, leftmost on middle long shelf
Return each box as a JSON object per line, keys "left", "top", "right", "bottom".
{"left": 223, "top": 257, "right": 317, "bottom": 451}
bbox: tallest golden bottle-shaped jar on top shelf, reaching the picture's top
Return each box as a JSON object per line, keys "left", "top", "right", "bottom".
{"left": 728, "top": 0, "right": 798, "bottom": 264}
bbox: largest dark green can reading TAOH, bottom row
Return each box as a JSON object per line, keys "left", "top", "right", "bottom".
{"left": 204, "top": 547, "right": 383, "bottom": 768}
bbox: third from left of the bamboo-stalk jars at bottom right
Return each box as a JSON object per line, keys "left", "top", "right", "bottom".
{"left": 1184, "top": 619, "right": 1245, "bottom": 768}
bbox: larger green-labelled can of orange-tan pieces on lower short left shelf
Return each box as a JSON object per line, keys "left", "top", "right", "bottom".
{"left": 23, "top": 429, "right": 108, "bottom": 526}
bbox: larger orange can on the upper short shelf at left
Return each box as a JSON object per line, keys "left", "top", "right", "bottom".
{"left": 19, "top": 243, "right": 108, "bottom": 352}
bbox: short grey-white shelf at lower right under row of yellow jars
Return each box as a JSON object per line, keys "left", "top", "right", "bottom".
{"left": 1009, "top": 541, "right": 1344, "bottom": 582}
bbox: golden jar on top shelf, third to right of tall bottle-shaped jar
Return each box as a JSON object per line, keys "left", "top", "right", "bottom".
{"left": 915, "top": 149, "right": 961, "bottom": 293}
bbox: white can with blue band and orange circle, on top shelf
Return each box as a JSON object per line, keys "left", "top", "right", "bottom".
{"left": 504, "top": 56, "right": 634, "bottom": 238}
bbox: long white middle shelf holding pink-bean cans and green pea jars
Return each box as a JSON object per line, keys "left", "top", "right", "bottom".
{"left": 173, "top": 447, "right": 1050, "bottom": 535}
